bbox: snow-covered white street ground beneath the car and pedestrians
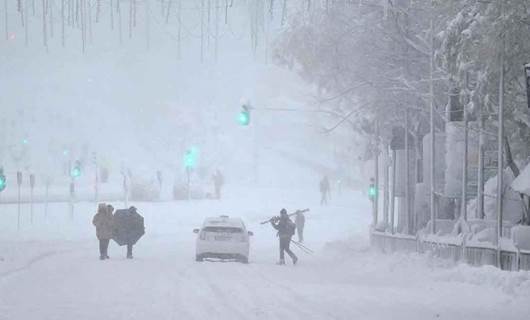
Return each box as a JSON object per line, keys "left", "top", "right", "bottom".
{"left": 0, "top": 189, "right": 530, "bottom": 320}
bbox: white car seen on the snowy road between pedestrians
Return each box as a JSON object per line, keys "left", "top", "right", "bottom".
{"left": 193, "top": 216, "right": 253, "bottom": 263}
